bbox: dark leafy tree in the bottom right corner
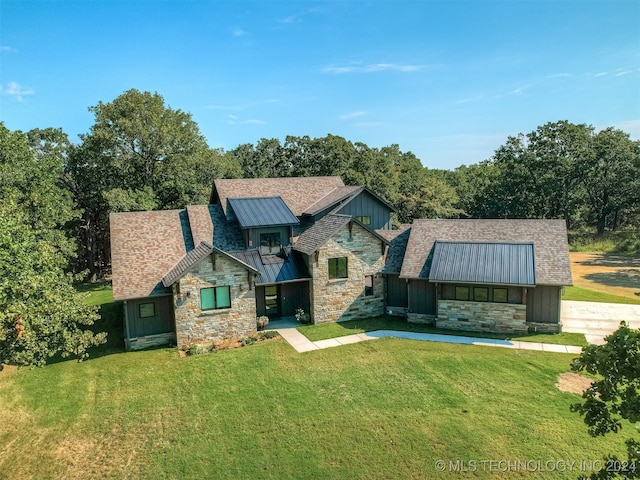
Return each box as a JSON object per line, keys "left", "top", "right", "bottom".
{"left": 571, "top": 322, "right": 640, "bottom": 479}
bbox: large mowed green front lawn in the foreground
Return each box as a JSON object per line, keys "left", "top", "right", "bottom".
{"left": 0, "top": 284, "right": 633, "bottom": 479}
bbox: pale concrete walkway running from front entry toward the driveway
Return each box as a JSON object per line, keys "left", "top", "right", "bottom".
{"left": 275, "top": 327, "right": 582, "bottom": 354}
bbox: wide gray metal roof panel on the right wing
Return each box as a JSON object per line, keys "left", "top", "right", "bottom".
{"left": 429, "top": 241, "right": 536, "bottom": 286}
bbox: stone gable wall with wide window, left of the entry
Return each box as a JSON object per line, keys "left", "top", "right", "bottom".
{"left": 173, "top": 254, "right": 257, "bottom": 347}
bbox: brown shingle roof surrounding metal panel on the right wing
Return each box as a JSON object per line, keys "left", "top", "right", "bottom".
{"left": 400, "top": 219, "right": 572, "bottom": 285}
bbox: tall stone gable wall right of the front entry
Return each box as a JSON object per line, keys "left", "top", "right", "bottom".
{"left": 308, "top": 223, "right": 384, "bottom": 324}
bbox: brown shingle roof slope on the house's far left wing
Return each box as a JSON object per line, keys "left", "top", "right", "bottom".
{"left": 109, "top": 210, "right": 186, "bottom": 300}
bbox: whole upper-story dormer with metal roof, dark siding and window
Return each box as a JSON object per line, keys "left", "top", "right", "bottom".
{"left": 227, "top": 196, "right": 300, "bottom": 255}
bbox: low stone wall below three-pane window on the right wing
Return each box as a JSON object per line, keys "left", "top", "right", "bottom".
{"left": 436, "top": 300, "right": 527, "bottom": 334}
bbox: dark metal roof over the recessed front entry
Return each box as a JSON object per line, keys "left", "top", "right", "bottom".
{"left": 228, "top": 249, "right": 311, "bottom": 285}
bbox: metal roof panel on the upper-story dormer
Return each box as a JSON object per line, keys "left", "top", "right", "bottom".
{"left": 227, "top": 197, "right": 300, "bottom": 228}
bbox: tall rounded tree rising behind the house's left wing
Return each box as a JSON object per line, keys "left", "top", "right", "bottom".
{"left": 66, "top": 89, "right": 241, "bottom": 278}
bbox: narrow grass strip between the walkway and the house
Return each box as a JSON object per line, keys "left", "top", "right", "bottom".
{"left": 298, "top": 315, "right": 588, "bottom": 347}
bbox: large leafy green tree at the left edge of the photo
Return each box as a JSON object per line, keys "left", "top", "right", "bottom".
{"left": 0, "top": 124, "right": 105, "bottom": 365}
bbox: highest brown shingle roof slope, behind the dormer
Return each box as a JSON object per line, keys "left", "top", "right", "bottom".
{"left": 214, "top": 177, "right": 344, "bottom": 217}
